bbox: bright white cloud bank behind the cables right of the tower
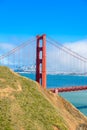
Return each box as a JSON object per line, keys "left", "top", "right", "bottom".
{"left": 47, "top": 40, "right": 87, "bottom": 73}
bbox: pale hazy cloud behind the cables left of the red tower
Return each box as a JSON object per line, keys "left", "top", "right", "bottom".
{"left": 0, "top": 43, "right": 36, "bottom": 66}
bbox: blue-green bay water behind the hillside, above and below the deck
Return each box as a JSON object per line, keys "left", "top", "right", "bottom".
{"left": 21, "top": 73, "right": 87, "bottom": 116}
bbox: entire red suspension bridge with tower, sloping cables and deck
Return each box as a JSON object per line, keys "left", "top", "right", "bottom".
{"left": 0, "top": 34, "right": 87, "bottom": 93}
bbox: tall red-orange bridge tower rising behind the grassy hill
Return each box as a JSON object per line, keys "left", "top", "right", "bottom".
{"left": 36, "top": 34, "right": 46, "bottom": 88}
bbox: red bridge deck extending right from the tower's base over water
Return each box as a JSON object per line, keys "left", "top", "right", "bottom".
{"left": 50, "top": 86, "right": 87, "bottom": 93}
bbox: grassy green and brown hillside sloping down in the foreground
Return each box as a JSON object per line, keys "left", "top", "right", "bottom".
{"left": 0, "top": 67, "right": 87, "bottom": 130}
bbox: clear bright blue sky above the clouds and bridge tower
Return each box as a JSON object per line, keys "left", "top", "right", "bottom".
{"left": 0, "top": 0, "right": 87, "bottom": 43}
